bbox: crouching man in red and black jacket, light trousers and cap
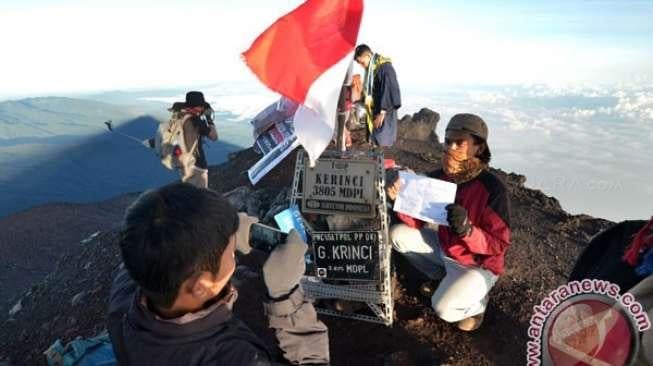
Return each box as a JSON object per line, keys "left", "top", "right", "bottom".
{"left": 387, "top": 114, "right": 510, "bottom": 331}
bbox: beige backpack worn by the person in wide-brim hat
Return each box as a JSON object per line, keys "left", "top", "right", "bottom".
{"left": 154, "top": 111, "right": 199, "bottom": 171}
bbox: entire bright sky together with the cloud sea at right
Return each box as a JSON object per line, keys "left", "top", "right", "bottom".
{"left": 0, "top": 0, "right": 653, "bottom": 220}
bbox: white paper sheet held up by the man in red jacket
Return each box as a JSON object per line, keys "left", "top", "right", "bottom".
{"left": 394, "top": 171, "right": 457, "bottom": 226}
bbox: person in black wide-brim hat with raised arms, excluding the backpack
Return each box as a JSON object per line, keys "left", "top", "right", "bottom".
{"left": 168, "top": 91, "right": 218, "bottom": 188}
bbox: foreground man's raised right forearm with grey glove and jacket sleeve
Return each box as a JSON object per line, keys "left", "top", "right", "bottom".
{"left": 263, "top": 230, "right": 329, "bottom": 365}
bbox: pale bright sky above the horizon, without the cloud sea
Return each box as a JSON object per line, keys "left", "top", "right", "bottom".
{"left": 0, "top": 0, "right": 653, "bottom": 99}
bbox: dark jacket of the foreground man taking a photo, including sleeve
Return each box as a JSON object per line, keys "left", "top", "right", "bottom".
{"left": 108, "top": 269, "right": 329, "bottom": 365}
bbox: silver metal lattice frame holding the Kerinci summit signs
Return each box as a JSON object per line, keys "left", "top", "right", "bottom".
{"left": 290, "top": 150, "right": 394, "bottom": 326}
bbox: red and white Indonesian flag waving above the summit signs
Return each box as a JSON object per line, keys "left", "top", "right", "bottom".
{"left": 243, "top": 0, "right": 363, "bottom": 166}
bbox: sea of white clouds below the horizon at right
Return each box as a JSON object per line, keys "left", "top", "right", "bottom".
{"left": 404, "top": 84, "right": 653, "bottom": 220}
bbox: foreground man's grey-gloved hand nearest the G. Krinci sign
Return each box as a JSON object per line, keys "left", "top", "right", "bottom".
{"left": 263, "top": 230, "right": 308, "bottom": 298}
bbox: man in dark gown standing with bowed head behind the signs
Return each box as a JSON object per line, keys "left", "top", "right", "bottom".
{"left": 354, "top": 44, "right": 401, "bottom": 146}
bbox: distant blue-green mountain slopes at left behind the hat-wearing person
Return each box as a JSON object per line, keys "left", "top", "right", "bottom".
{"left": 0, "top": 97, "right": 251, "bottom": 217}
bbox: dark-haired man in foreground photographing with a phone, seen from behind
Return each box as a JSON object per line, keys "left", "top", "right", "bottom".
{"left": 108, "top": 183, "right": 329, "bottom": 365}
